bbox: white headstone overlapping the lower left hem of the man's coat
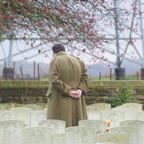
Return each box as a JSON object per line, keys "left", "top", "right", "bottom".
{"left": 39, "top": 119, "right": 66, "bottom": 134}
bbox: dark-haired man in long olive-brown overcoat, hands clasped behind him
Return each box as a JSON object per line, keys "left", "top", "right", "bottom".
{"left": 46, "top": 44, "right": 89, "bottom": 127}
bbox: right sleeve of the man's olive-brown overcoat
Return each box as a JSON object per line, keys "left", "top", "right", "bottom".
{"left": 78, "top": 61, "right": 89, "bottom": 95}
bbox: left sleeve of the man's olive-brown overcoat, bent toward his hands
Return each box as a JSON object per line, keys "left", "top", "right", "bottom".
{"left": 50, "top": 60, "right": 71, "bottom": 95}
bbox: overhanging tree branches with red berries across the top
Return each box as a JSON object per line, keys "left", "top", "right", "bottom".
{"left": 0, "top": 0, "right": 143, "bottom": 65}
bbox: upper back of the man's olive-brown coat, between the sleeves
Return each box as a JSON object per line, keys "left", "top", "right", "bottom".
{"left": 55, "top": 55, "right": 82, "bottom": 87}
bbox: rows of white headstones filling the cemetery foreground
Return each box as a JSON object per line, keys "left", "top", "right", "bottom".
{"left": 0, "top": 103, "right": 144, "bottom": 144}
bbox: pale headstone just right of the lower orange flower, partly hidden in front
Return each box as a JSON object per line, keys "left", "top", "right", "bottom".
{"left": 110, "top": 127, "right": 138, "bottom": 144}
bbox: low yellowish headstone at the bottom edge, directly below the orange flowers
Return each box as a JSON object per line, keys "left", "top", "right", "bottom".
{"left": 97, "top": 133, "right": 129, "bottom": 144}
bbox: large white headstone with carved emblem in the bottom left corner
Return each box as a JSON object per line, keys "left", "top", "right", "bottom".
{"left": 0, "top": 120, "right": 25, "bottom": 144}
